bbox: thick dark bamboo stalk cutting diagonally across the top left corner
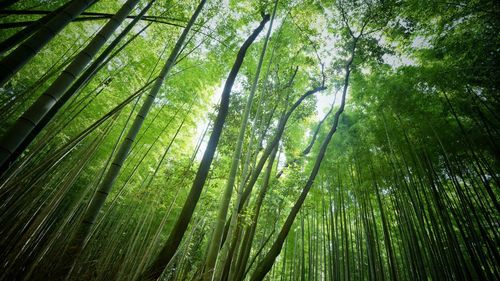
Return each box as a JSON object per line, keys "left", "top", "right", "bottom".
{"left": 0, "top": 0, "right": 98, "bottom": 86}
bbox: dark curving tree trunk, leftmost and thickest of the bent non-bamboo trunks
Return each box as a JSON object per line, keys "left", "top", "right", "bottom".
{"left": 139, "top": 15, "right": 269, "bottom": 280}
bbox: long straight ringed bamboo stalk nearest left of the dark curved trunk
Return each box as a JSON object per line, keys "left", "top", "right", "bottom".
{"left": 51, "top": 0, "right": 206, "bottom": 275}
